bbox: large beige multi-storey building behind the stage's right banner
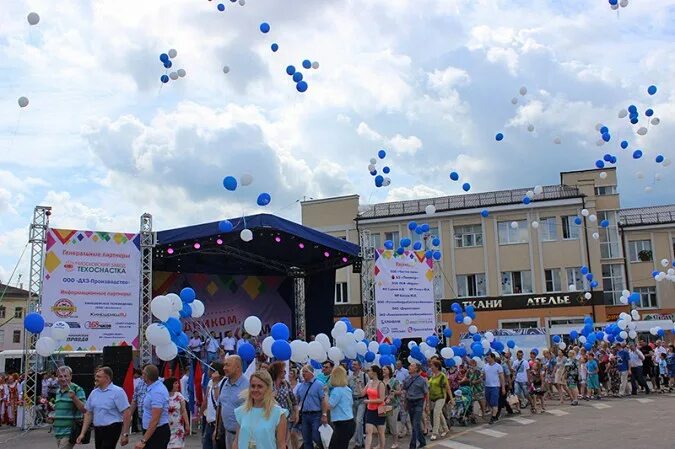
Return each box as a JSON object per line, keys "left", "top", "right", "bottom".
{"left": 301, "top": 168, "right": 675, "bottom": 342}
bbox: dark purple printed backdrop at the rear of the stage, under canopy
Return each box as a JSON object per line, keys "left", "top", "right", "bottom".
{"left": 153, "top": 271, "right": 291, "bottom": 338}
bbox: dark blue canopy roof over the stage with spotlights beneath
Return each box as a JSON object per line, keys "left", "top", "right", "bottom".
{"left": 153, "top": 214, "right": 361, "bottom": 276}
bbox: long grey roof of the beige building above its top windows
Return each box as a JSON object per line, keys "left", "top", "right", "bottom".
{"left": 357, "top": 184, "right": 583, "bottom": 220}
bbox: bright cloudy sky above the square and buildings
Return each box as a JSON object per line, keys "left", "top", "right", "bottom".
{"left": 0, "top": 0, "right": 675, "bottom": 285}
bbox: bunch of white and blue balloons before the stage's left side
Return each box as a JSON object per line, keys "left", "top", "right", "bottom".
{"left": 145, "top": 287, "right": 204, "bottom": 361}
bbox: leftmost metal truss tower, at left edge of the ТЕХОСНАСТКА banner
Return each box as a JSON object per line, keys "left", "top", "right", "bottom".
{"left": 22, "top": 206, "right": 52, "bottom": 430}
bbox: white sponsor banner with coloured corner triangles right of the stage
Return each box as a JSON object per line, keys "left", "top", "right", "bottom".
{"left": 374, "top": 249, "right": 436, "bottom": 340}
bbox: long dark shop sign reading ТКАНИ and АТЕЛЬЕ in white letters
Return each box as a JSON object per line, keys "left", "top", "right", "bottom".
{"left": 442, "top": 291, "right": 603, "bottom": 313}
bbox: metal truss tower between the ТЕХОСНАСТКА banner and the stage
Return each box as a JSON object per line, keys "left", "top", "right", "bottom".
{"left": 138, "top": 213, "right": 156, "bottom": 366}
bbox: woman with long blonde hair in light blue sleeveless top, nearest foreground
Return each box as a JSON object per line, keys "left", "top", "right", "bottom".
{"left": 233, "top": 370, "right": 288, "bottom": 449}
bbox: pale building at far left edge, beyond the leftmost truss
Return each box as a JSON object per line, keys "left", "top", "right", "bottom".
{"left": 0, "top": 283, "right": 28, "bottom": 351}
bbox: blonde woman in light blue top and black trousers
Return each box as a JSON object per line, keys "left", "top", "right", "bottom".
{"left": 326, "top": 365, "right": 356, "bottom": 449}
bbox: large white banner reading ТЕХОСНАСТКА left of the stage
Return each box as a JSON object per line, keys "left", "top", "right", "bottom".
{"left": 41, "top": 229, "right": 141, "bottom": 351}
